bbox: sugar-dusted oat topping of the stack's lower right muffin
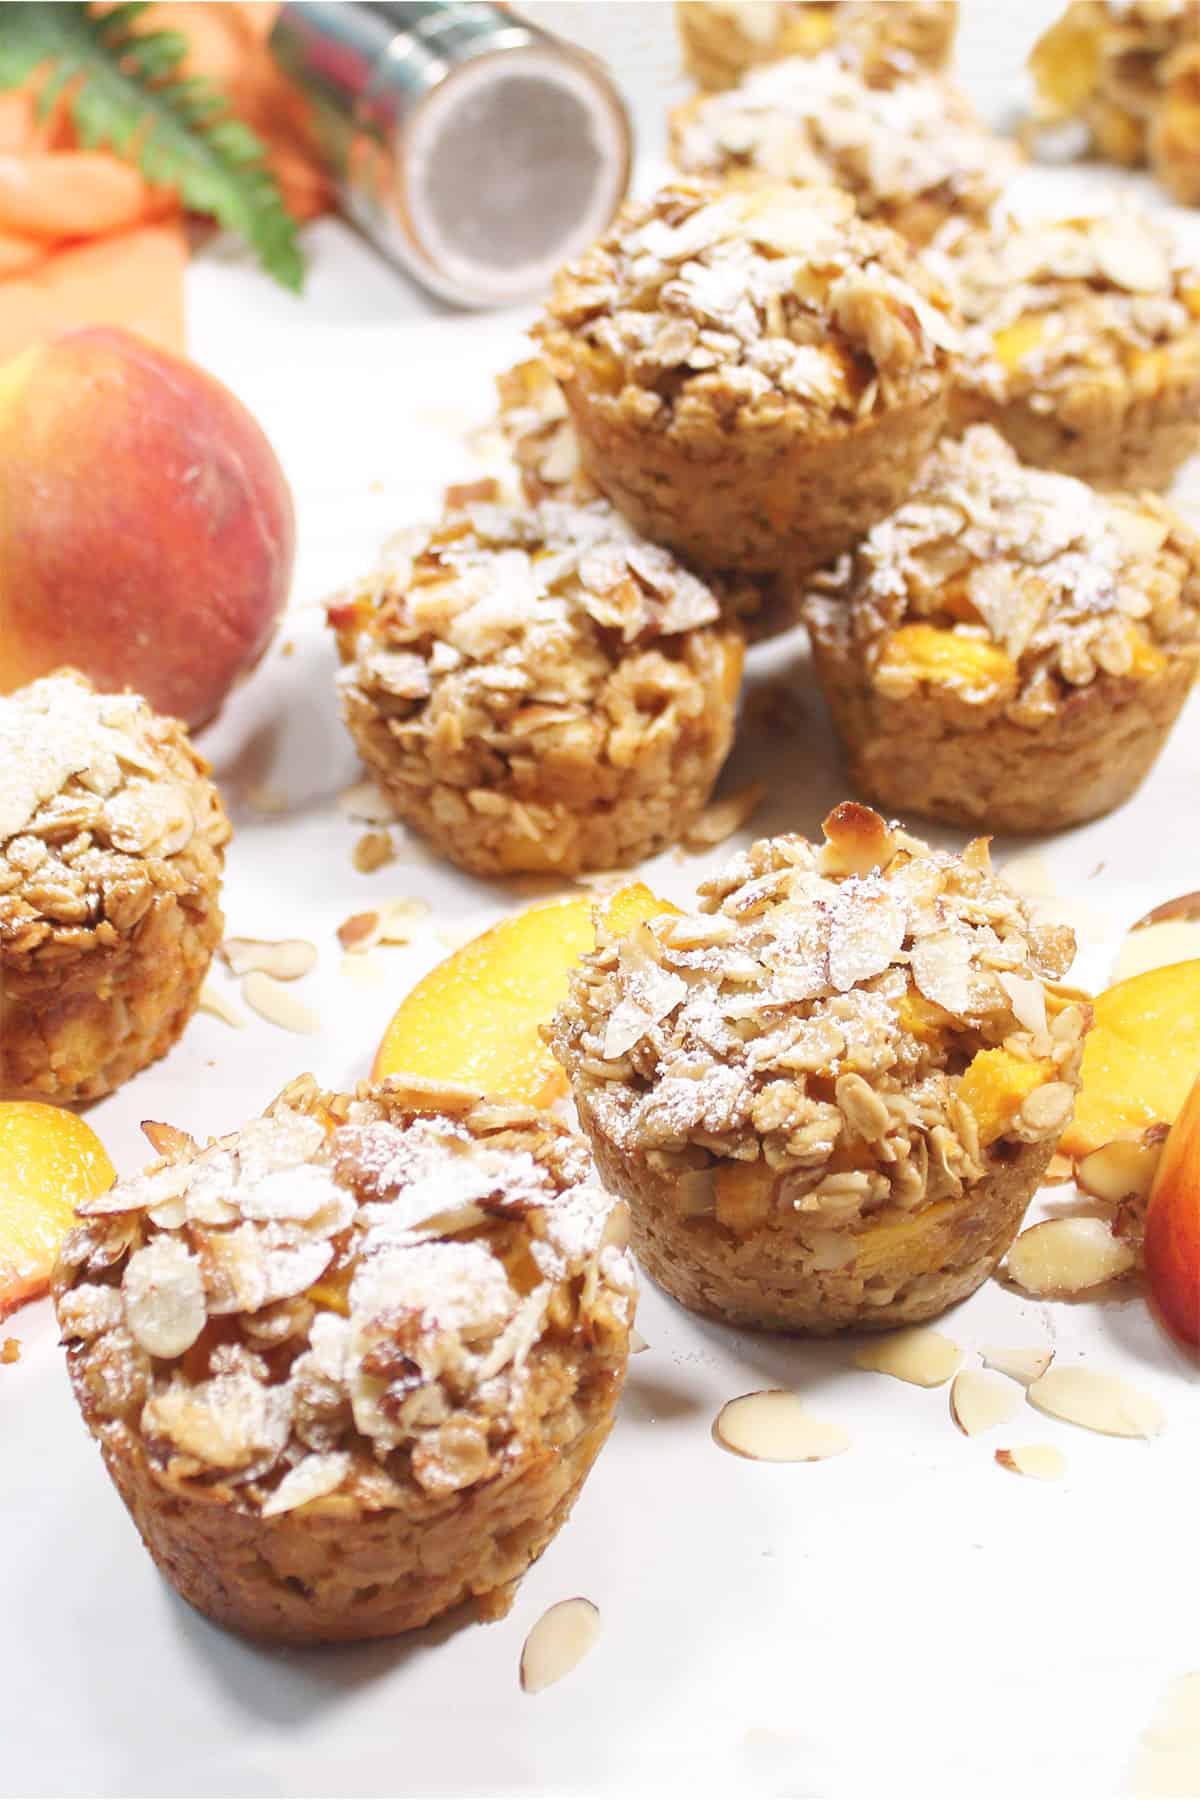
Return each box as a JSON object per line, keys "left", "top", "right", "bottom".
{"left": 804, "top": 425, "right": 1200, "bottom": 727}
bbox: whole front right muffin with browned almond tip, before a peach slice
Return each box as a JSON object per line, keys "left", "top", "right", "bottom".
{"left": 551, "top": 803, "right": 1088, "bottom": 1332}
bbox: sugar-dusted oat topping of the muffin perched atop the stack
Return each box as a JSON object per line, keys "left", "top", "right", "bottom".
{"left": 534, "top": 180, "right": 959, "bottom": 428}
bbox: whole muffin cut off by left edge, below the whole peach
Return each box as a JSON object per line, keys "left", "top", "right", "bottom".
{"left": 0, "top": 670, "right": 230, "bottom": 1103}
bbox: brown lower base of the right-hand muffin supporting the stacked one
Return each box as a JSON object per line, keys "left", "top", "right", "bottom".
{"left": 813, "top": 635, "right": 1195, "bottom": 832}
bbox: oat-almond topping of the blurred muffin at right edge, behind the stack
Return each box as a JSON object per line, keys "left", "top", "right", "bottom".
{"left": 937, "top": 209, "right": 1200, "bottom": 419}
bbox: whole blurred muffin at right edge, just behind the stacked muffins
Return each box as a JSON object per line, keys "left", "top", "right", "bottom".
{"left": 937, "top": 209, "right": 1200, "bottom": 488}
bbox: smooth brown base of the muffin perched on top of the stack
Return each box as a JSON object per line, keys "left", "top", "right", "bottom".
{"left": 556, "top": 378, "right": 946, "bottom": 576}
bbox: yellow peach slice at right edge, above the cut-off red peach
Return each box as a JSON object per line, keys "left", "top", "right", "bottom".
{"left": 1060, "top": 959, "right": 1200, "bottom": 1156}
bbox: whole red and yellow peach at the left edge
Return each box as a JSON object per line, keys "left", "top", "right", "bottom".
{"left": 0, "top": 328, "right": 295, "bottom": 725}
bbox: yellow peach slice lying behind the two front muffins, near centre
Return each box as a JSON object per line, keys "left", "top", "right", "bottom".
{"left": 372, "top": 882, "right": 678, "bottom": 1107}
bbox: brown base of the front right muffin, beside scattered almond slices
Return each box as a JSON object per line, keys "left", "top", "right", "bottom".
{"left": 583, "top": 1118, "right": 1054, "bottom": 1336}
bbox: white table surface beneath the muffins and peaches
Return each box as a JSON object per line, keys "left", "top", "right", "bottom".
{"left": 0, "top": 0, "right": 1200, "bottom": 1800}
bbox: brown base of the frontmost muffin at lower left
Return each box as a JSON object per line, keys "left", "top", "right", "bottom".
{"left": 89, "top": 1379, "right": 621, "bottom": 1643}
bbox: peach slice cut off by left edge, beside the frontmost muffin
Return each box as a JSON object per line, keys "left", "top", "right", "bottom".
{"left": 0, "top": 1100, "right": 117, "bottom": 1319}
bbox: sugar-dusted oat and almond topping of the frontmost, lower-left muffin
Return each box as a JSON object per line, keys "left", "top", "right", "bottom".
{"left": 56, "top": 1076, "right": 635, "bottom": 1519}
